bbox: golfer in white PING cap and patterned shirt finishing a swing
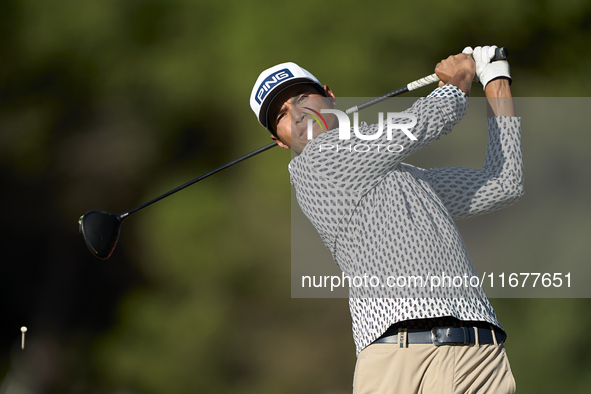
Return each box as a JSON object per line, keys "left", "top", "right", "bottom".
{"left": 250, "top": 46, "right": 523, "bottom": 394}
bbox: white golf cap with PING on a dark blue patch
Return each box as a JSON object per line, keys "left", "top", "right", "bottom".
{"left": 250, "top": 62, "right": 322, "bottom": 132}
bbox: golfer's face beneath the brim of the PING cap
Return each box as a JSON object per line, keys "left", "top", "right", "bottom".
{"left": 268, "top": 84, "right": 337, "bottom": 154}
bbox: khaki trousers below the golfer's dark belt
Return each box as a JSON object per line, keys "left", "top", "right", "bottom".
{"left": 353, "top": 343, "right": 515, "bottom": 394}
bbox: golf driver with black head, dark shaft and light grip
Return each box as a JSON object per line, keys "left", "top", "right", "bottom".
{"left": 78, "top": 48, "right": 508, "bottom": 260}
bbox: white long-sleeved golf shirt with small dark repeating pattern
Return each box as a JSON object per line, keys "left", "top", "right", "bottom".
{"left": 289, "top": 85, "right": 523, "bottom": 353}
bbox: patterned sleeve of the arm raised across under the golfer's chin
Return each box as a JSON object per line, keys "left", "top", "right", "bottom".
{"left": 299, "top": 85, "right": 468, "bottom": 192}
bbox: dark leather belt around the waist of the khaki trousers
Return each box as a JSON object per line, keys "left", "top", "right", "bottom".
{"left": 373, "top": 327, "right": 507, "bottom": 347}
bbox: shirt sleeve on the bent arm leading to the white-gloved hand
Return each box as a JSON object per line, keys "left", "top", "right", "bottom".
{"left": 423, "top": 116, "right": 524, "bottom": 218}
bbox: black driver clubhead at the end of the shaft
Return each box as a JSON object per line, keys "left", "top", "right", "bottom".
{"left": 78, "top": 211, "right": 121, "bottom": 260}
